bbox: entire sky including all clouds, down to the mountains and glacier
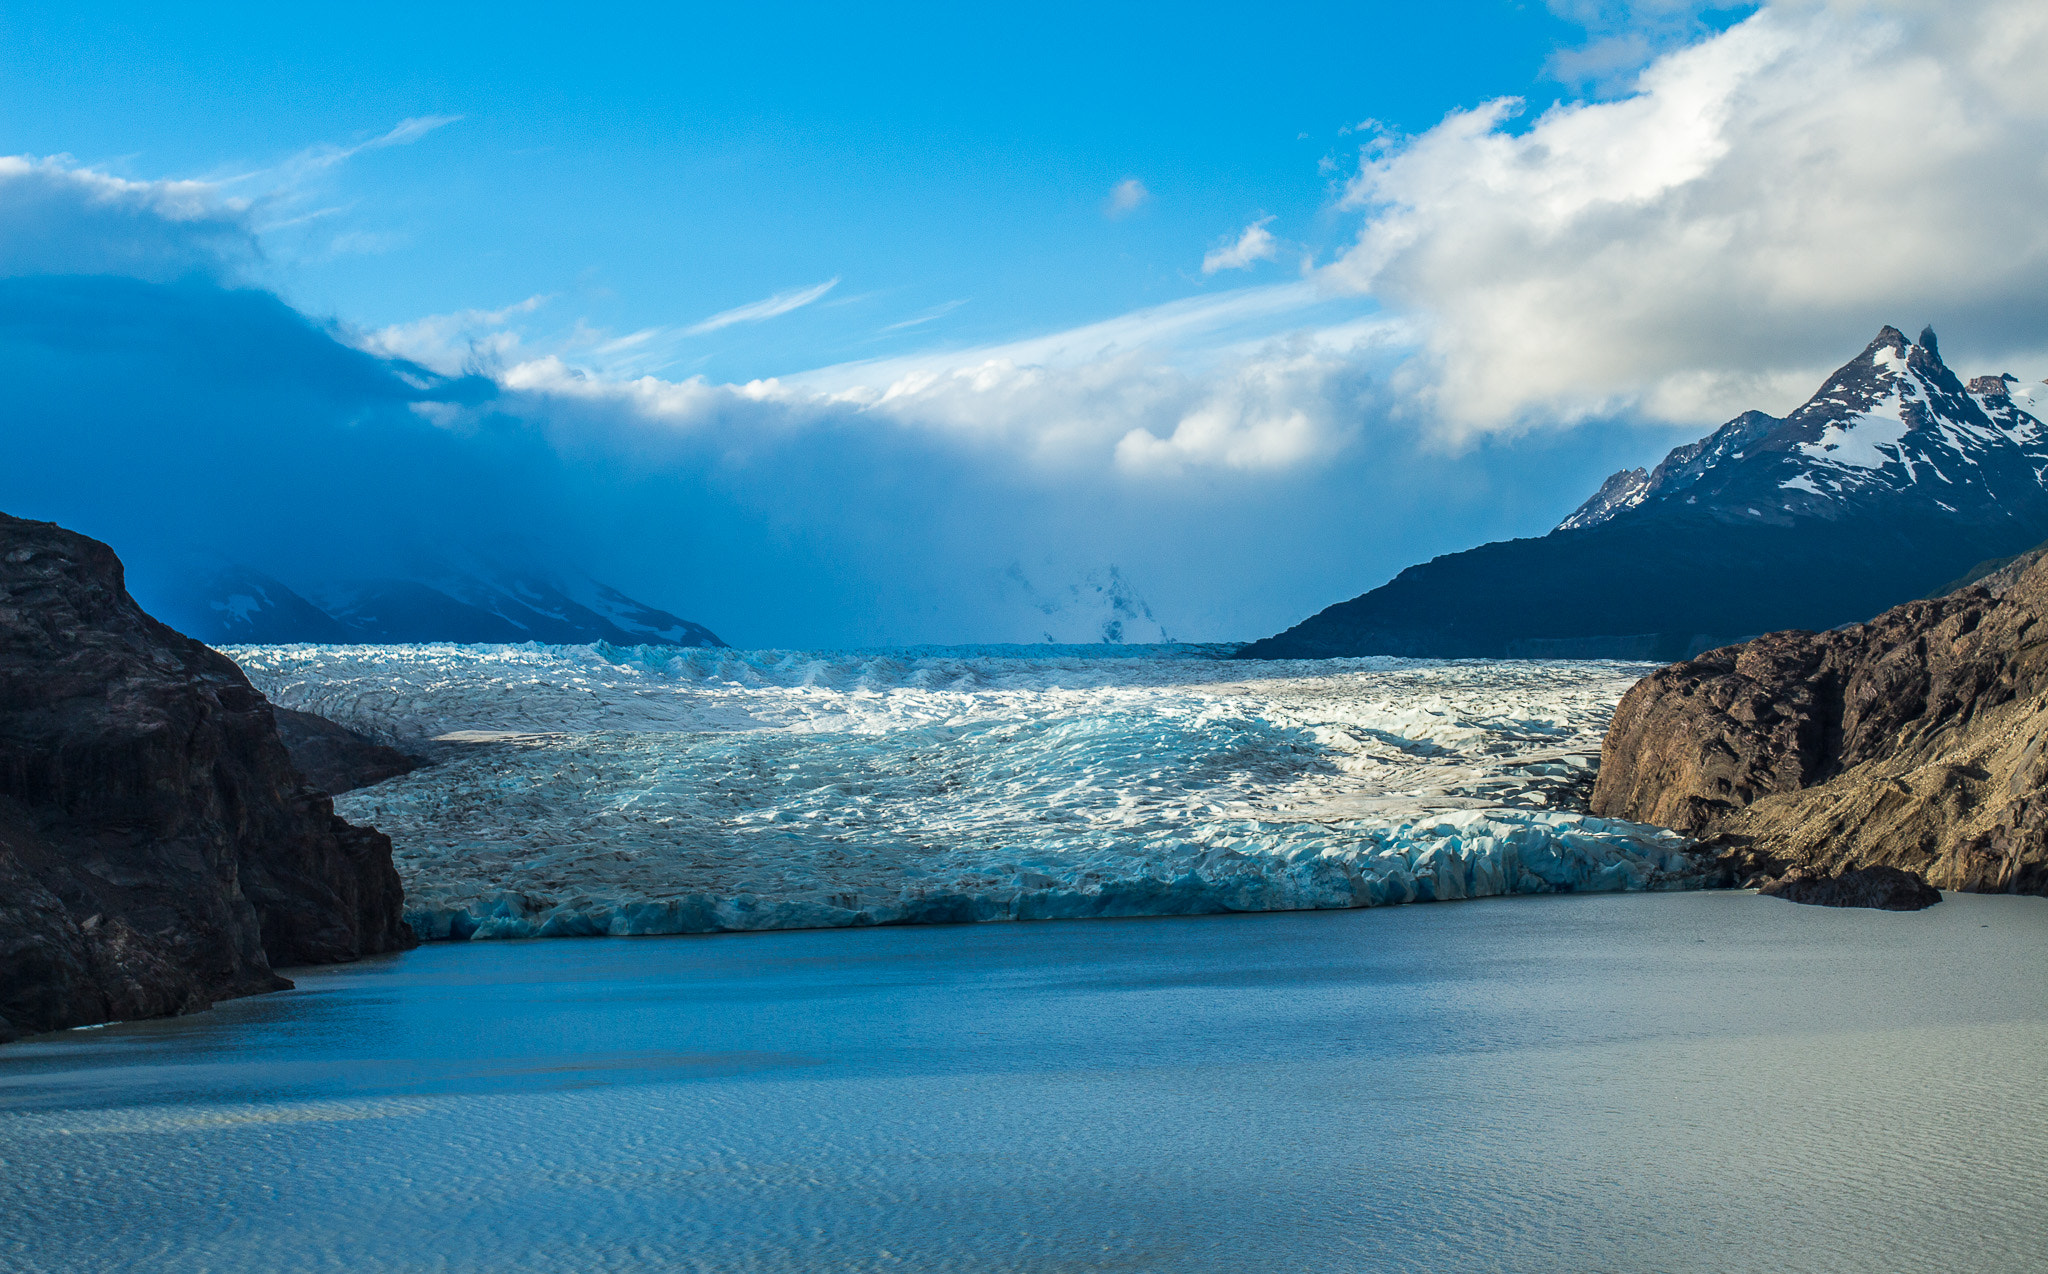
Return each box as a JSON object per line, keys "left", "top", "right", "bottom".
{"left": 0, "top": 0, "right": 2048, "bottom": 647}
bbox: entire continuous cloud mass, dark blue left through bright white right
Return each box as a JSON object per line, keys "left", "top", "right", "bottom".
{"left": 0, "top": 2, "right": 2048, "bottom": 645}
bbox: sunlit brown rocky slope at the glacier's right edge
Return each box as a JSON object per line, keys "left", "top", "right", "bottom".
{"left": 1593, "top": 557, "right": 2048, "bottom": 893}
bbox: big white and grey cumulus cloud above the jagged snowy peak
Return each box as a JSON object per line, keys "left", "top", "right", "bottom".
{"left": 1325, "top": 0, "right": 2048, "bottom": 436}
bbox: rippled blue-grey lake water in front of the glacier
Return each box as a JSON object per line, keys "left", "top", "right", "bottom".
{"left": 0, "top": 891, "right": 2048, "bottom": 1274}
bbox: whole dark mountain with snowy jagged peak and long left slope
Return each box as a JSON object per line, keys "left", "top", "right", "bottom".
{"left": 1239, "top": 328, "right": 2048, "bottom": 660}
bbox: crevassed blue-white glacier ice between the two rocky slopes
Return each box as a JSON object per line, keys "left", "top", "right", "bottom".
{"left": 229, "top": 645, "right": 1696, "bottom": 938}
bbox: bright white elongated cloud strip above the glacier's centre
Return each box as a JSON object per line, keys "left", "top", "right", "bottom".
{"left": 500, "top": 283, "right": 1407, "bottom": 477}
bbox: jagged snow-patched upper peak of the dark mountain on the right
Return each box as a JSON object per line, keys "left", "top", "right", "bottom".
{"left": 1559, "top": 326, "right": 2048, "bottom": 530}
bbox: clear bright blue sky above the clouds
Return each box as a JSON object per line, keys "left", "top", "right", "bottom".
{"left": 0, "top": 0, "right": 1613, "bottom": 381}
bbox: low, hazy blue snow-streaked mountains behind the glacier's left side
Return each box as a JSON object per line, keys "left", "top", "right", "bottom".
{"left": 150, "top": 565, "right": 725, "bottom": 645}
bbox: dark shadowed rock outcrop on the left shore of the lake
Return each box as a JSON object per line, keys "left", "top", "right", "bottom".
{"left": 0, "top": 514, "right": 414, "bottom": 1038}
